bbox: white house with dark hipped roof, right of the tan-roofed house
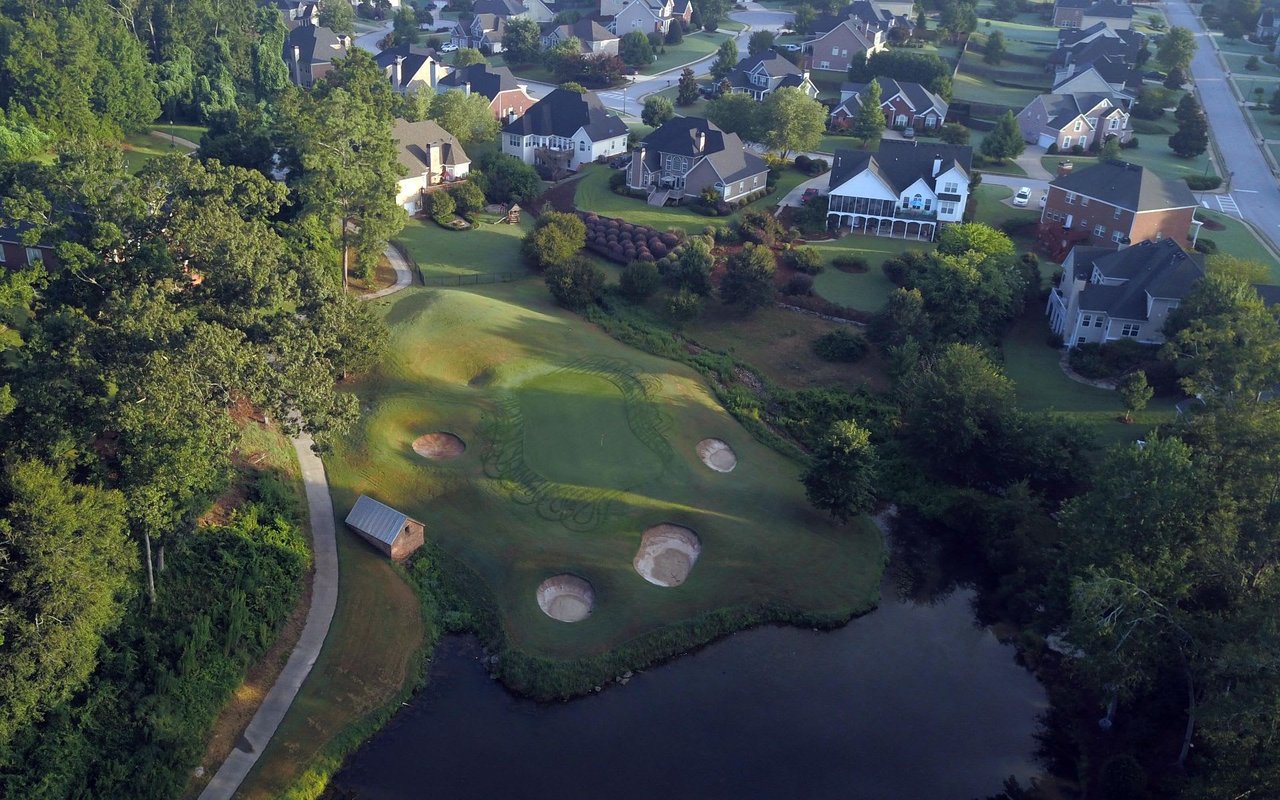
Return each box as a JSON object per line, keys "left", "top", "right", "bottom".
{"left": 502, "top": 88, "right": 630, "bottom": 175}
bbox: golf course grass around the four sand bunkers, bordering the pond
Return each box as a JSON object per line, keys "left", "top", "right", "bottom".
{"left": 326, "top": 280, "right": 883, "bottom": 662}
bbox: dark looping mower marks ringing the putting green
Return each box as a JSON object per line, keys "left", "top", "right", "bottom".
{"left": 483, "top": 357, "right": 675, "bottom": 532}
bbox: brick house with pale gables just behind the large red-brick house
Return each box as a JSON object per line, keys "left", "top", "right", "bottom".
{"left": 1018, "top": 93, "right": 1133, "bottom": 152}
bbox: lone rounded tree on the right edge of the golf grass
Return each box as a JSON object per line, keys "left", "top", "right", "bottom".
{"left": 800, "top": 420, "right": 879, "bottom": 522}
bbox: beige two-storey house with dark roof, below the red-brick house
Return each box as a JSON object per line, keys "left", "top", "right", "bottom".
{"left": 1044, "top": 239, "right": 1204, "bottom": 347}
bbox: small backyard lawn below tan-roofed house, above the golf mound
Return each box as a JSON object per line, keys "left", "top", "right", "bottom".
{"left": 397, "top": 214, "right": 532, "bottom": 280}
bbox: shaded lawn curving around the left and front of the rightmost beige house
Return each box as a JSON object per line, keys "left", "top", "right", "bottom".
{"left": 1001, "top": 313, "right": 1175, "bottom": 445}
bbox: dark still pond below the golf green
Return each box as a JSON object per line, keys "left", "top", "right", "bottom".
{"left": 334, "top": 576, "right": 1046, "bottom": 800}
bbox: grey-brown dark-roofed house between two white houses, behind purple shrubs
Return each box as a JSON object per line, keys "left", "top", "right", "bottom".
{"left": 627, "top": 116, "right": 769, "bottom": 205}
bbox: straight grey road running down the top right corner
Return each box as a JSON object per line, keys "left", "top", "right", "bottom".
{"left": 1165, "top": 0, "right": 1280, "bottom": 248}
